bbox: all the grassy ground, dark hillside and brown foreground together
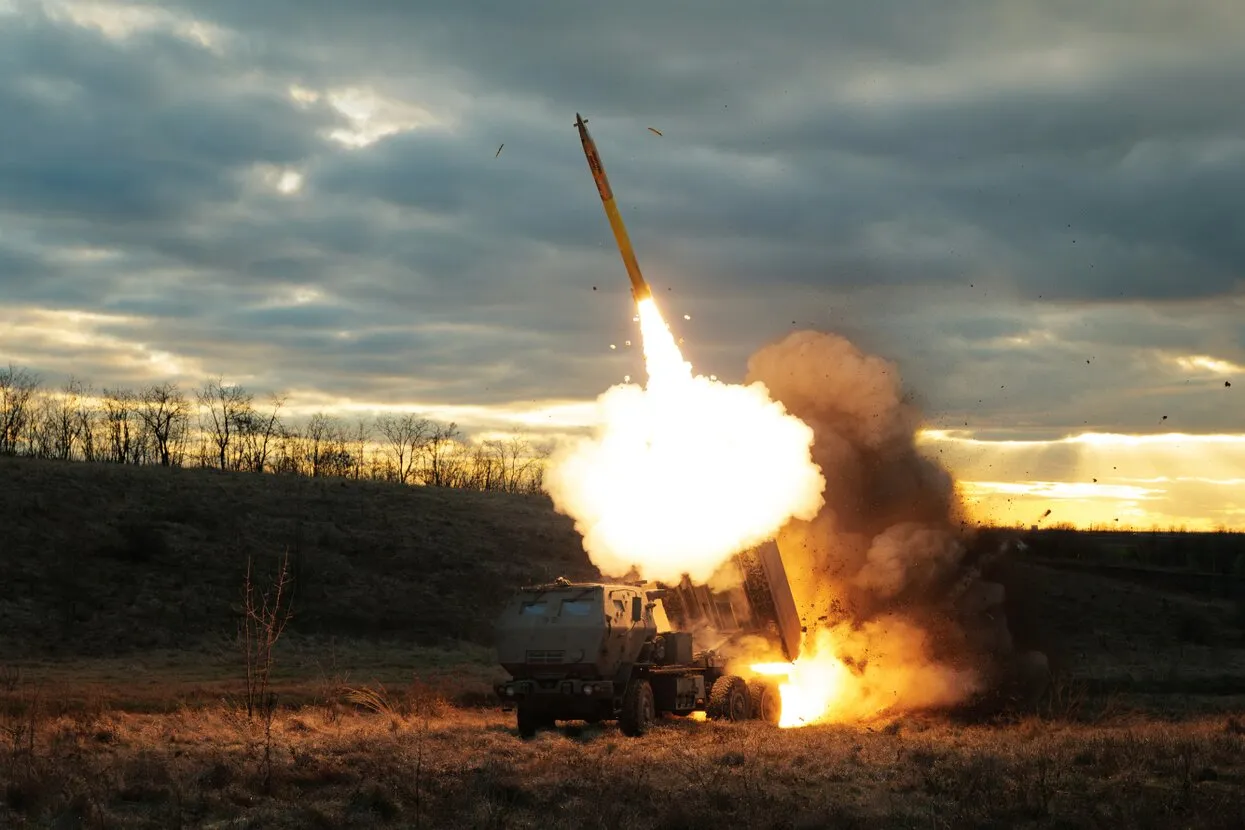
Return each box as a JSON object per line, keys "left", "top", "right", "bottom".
{"left": 0, "top": 458, "right": 1245, "bottom": 829}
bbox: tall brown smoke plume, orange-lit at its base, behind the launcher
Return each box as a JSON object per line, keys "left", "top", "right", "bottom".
{"left": 747, "top": 331, "right": 1035, "bottom": 717}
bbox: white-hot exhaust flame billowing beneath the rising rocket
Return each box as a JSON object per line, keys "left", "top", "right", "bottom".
{"left": 545, "top": 297, "right": 825, "bottom": 584}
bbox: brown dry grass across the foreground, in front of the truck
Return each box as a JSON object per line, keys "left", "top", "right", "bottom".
{"left": 0, "top": 689, "right": 1245, "bottom": 829}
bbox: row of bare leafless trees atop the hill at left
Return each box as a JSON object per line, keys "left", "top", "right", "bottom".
{"left": 0, "top": 365, "right": 548, "bottom": 493}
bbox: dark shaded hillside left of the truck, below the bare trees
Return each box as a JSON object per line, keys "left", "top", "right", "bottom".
{"left": 0, "top": 458, "right": 595, "bottom": 658}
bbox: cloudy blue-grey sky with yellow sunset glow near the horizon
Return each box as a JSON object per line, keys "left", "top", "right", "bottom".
{"left": 0, "top": 0, "right": 1245, "bottom": 529}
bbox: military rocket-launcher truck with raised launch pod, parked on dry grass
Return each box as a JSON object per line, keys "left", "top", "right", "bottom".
{"left": 494, "top": 541, "right": 802, "bottom": 738}
